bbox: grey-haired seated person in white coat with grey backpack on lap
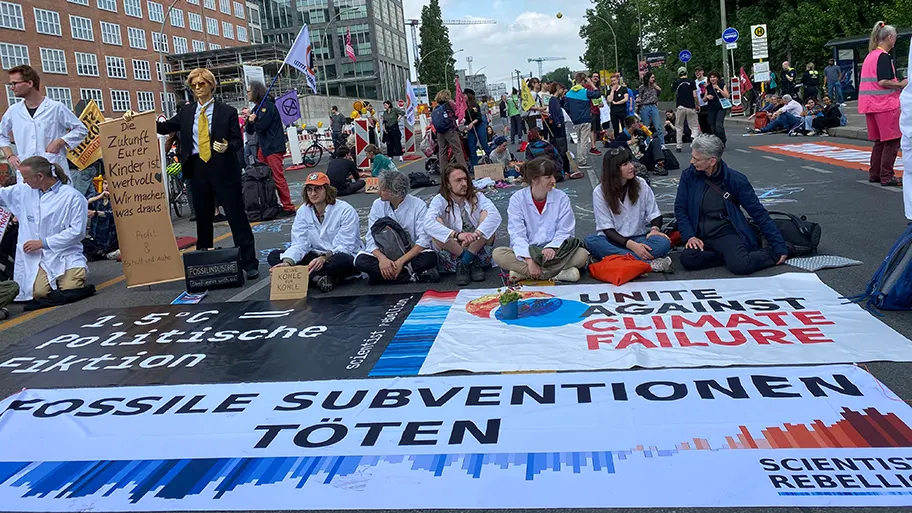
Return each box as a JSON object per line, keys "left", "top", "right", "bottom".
{"left": 355, "top": 170, "right": 440, "bottom": 284}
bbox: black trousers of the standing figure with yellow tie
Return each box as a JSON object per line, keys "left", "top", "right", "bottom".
{"left": 187, "top": 155, "right": 259, "bottom": 270}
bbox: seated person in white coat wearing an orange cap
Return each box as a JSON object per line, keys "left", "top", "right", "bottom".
{"left": 266, "top": 173, "right": 361, "bottom": 292}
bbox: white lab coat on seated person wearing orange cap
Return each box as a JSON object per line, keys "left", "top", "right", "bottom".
{"left": 281, "top": 200, "right": 361, "bottom": 262}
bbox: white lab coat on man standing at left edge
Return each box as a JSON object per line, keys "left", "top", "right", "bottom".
{"left": 0, "top": 97, "right": 89, "bottom": 183}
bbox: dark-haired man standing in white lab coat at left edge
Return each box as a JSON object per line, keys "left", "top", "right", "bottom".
{"left": 0, "top": 65, "right": 89, "bottom": 183}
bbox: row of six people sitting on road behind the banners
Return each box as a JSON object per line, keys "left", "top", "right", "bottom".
{"left": 268, "top": 135, "right": 787, "bottom": 291}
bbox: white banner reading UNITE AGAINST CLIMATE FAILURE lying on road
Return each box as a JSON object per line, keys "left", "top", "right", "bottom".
{"left": 420, "top": 273, "right": 912, "bottom": 374}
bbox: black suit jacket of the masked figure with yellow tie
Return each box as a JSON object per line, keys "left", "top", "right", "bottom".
{"left": 157, "top": 101, "right": 244, "bottom": 183}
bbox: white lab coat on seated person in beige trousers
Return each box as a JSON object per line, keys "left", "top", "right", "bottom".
{"left": 507, "top": 187, "right": 576, "bottom": 260}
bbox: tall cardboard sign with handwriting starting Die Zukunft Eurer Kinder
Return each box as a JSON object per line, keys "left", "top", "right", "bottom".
{"left": 99, "top": 111, "right": 184, "bottom": 287}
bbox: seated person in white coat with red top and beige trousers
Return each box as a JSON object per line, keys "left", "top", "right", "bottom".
{"left": 494, "top": 156, "right": 589, "bottom": 281}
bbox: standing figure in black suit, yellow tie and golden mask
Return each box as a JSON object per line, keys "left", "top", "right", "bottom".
{"left": 149, "top": 68, "right": 260, "bottom": 279}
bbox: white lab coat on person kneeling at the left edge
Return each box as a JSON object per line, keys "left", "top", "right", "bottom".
{"left": 0, "top": 183, "right": 89, "bottom": 301}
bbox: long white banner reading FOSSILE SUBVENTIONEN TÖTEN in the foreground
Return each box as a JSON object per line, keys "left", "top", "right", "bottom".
{"left": 0, "top": 365, "right": 912, "bottom": 511}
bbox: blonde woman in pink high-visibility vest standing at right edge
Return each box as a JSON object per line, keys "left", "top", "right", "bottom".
{"left": 858, "top": 21, "right": 908, "bottom": 187}
